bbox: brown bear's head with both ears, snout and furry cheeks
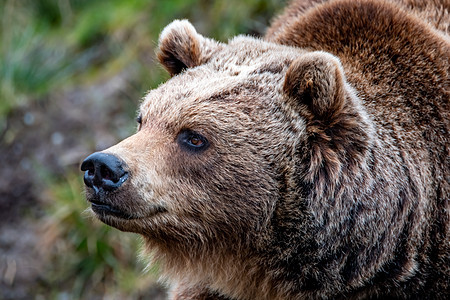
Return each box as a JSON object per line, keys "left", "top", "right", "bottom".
{"left": 82, "top": 21, "right": 371, "bottom": 288}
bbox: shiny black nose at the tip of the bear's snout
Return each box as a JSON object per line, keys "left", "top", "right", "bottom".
{"left": 81, "top": 152, "right": 128, "bottom": 192}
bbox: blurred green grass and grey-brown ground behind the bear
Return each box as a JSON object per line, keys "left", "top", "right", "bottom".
{"left": 0, "top": 0, "right": 285, "bottom": 299}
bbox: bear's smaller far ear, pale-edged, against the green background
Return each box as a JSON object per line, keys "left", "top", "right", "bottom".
{"left": 158, "top": 20, "right": 221, "bottom": 76}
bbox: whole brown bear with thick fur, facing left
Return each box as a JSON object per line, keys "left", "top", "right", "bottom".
{"left": 81, "top": 0, "right": 450, "bottom": 300}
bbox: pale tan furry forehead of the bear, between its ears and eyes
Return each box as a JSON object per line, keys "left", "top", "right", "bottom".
{"left": 140, "top": 36, "right": 305, "bottom": 126}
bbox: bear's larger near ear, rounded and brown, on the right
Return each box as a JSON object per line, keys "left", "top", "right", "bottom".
{"left": 283, "top": 51, "right": 346, "bottom": 123}
